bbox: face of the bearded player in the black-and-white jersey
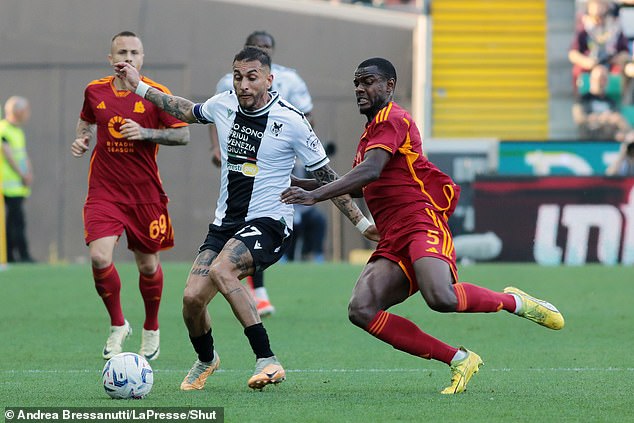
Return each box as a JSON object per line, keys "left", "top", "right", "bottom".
{"left": 233, "top": 60, "right": 273, "bottom": 110}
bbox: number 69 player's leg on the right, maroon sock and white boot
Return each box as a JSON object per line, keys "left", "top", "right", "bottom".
{"left": 134, "top": 250, "right": 163, "bottom": 360}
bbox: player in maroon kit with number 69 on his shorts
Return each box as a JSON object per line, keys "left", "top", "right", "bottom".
{"left": 71, "top": 31, "right": 189, "bottom": 360}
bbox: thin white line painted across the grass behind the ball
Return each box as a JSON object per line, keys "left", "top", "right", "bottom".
{"left": 0, "top": 367, "right": 634, "bottom": 374}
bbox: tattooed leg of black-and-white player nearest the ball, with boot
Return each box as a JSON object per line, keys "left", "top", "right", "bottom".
{"left": 181, "top": 249, "right": 220, "bottom": 391}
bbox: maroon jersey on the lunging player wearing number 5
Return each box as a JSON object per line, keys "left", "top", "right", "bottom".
{"left": 353, "top": 102, "right": 460, "bottom": 236}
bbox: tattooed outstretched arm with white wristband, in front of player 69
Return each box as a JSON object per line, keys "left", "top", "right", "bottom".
{"left": 114, "top": 62, "right": 198, "bottom": 123}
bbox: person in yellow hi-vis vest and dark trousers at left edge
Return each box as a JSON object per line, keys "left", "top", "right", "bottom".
{"left": 0, "top": 96, "right": 34, "bottom": 263}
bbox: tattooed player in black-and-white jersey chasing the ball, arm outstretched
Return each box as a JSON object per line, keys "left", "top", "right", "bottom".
{"left": 115, "top": 47, "right": 378, "bottom": 390}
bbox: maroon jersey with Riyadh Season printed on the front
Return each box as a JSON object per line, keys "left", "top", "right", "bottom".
{"left": 80, "top": 76, "right": 187, "bottom": 204}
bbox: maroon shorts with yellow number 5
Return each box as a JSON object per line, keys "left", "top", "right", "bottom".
{"left": 370, "top": 208, "right": 458, "bottom": 295}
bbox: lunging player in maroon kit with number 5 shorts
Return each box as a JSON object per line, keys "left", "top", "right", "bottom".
{"left": 281, "top": 58, "right": 564, "bottom": 394}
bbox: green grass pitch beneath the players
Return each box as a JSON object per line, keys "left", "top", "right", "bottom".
{"left": 0, "top": 263, "right": 634, "bottom": 422}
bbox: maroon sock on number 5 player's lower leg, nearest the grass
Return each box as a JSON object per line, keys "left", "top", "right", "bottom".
{"left": 367, "top": 310, "right": 457, "bottom": 364}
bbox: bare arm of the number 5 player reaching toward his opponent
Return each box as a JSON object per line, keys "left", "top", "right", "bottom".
{"left": 281, "top": 148, "right": 391, "bottom": 205}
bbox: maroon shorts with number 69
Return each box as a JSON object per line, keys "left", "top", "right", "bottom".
{"left": 84, "top": 200, "right": 174, "bottom": 254}
